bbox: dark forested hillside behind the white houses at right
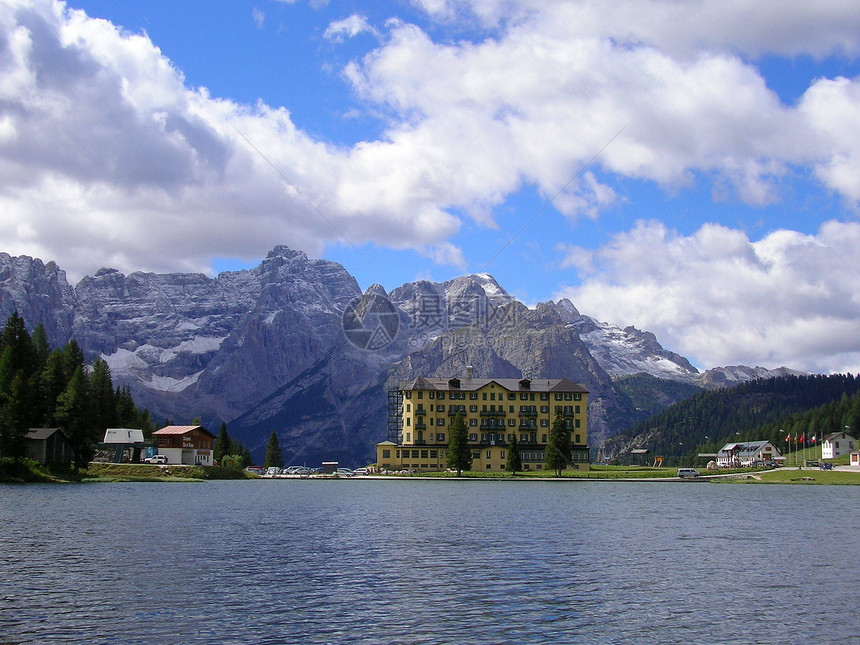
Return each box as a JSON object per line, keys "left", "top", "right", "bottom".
{"left": 600, "top": 374, "right": 860, "bottom": 458}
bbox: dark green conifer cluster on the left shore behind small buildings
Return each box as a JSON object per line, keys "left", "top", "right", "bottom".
{"left": 0, "top": 311, "right": 153, "bottom": 467}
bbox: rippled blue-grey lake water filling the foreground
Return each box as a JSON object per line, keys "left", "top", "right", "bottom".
{"left": 0, "top": 480, "right": 860, "bottom": 644}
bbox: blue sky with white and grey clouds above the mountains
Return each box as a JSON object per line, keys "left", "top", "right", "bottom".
{"left": 0, "top": 0, "right": 860, "bottom": 372}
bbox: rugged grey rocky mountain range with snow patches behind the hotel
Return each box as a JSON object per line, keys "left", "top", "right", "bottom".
{"left": 0, "top": 246, "right": 796, "bottom": 465}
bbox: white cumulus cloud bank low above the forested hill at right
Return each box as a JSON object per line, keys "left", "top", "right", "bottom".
{"left": 559, "top": 221, "right": 860, "bottom": 372}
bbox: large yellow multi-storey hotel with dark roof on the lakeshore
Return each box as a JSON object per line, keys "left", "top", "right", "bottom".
{"left": 376, "top": 369, "right": 589, "bottom": 472}
